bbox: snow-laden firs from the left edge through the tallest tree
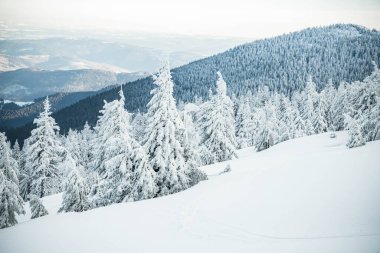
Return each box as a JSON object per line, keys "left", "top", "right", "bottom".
{"left": 0, "top": 64, "right": 207, "bottom": 227}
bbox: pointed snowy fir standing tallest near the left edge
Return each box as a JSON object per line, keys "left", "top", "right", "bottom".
{"left": 25, "top": 97, "right": 64, "bottom": 197}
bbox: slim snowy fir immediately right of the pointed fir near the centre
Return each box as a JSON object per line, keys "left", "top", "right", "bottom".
{"left": 236, "top": 96, "right": 256, "bottom": 148}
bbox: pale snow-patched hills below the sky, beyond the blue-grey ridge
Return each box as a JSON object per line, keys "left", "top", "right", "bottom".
{"left": 0, "top": 35, "right": 248, "bottom": 73}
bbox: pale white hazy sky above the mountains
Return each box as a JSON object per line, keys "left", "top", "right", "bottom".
{"left": 0, "top": 0, "right": 380, "bottom": 38}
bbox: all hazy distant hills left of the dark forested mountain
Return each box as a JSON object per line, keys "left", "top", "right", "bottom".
{"left": 0, "top": 35, "right": 248, "bottom": 101}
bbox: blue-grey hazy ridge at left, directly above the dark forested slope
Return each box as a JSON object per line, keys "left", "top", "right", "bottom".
{"left": 0, "top": 69, "right": 147, "bottom": 101}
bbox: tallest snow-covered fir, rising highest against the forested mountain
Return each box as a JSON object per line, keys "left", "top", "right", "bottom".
{"left": 144, "top": 64, "right": 190, "bottom": 196}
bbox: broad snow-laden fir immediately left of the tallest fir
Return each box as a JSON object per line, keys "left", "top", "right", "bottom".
{"left": 92, "top": 89, "right": 157, "bottom": 206}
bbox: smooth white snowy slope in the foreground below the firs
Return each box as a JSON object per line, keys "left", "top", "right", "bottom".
{"left": 0, "top": 132, "right": 380, "bottom": 253}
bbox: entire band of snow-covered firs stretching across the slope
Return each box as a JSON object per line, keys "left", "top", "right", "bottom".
{"left": 0, "top": 61, "right": 380, "bottom": 227}
